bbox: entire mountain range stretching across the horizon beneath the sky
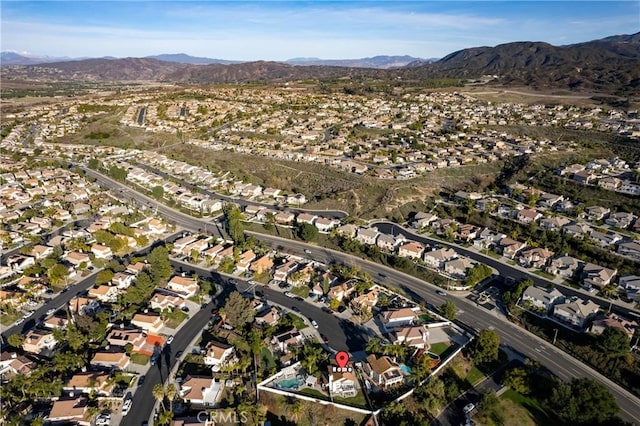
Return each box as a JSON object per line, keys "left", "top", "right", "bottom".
{"left": 2, "top": 33, "right": 640, "bottom": 96}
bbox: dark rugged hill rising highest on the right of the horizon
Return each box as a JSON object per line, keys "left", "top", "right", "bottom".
{"left": 406, "top": 33, "right": 640, "bottom": 94}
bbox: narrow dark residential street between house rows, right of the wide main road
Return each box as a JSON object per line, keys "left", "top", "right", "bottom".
{"left": 372, "top": 222, "right": 639, "bottom": 315}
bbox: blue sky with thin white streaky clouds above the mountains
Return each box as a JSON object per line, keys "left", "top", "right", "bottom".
{"left": 0, "top": 0, "right": 640, "bottom": 60}
